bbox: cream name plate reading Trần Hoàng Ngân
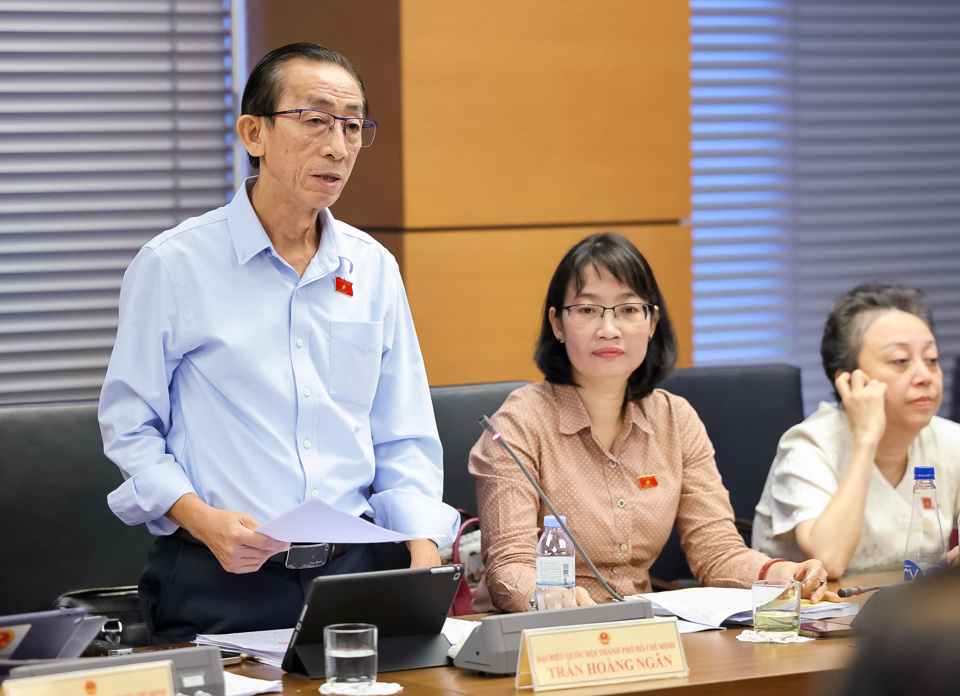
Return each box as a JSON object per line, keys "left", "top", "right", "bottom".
{"left": 516, "top": 617, "right": 690, "bottom": 691}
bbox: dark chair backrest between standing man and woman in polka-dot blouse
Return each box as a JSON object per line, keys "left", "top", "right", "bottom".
{"left": 430, "top": 382, "right": 527, "bottom": 519}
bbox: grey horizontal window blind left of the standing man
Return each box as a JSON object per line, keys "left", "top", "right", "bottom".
{"left": 0, "top": 0, "right": 233, "bottom": 403}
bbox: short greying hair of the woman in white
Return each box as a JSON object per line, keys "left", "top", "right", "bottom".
{"left": 820, "top": 283, "right": 936, "bottom": 403}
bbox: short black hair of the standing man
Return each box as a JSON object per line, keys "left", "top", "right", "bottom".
{"left": 240, "top": 42, "right": 369, "bottom": 169}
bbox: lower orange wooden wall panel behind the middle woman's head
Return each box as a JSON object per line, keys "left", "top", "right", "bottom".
{"left": 403, "top": 225, "right": 691, "bottom": 384}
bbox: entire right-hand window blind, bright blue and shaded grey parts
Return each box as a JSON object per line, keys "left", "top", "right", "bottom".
{"left": 690, "top": 0, "right": 960, "bottom": 413}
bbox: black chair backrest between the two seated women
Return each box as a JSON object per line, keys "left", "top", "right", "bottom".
{"left": 650, "top": 365, "right": 803, "bottom": 580}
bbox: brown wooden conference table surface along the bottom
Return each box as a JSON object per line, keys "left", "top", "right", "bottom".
{"left": 231, "top": 572, "right": 902, "bottom": 696}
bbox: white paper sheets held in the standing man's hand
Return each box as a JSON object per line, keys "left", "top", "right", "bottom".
{"left": 257, "top": 500, "right": 422, "bottom": 544}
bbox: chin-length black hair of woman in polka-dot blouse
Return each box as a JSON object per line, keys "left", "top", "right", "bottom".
{"left": 534, "top": 232, "right": 677, "bottom": 401}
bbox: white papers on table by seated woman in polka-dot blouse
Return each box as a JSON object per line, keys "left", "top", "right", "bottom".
{"left": 637, "top": 587, "right": 859, "bottom": 628}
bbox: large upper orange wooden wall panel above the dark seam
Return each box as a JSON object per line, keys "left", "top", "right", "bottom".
{"left": 401, "top": 0, "right": 690, "bottom": 229}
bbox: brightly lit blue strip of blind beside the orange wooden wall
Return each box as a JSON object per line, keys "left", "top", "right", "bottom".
{"left": 690, "top": 0, "right": 793, "bottom": 365}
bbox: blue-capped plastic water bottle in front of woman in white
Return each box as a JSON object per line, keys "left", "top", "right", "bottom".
{"left": 903, "top": 466, "right": 946, "bottom": 581}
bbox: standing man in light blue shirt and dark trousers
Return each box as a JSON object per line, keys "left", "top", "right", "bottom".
{"left": 100, "top": 44, "right": 459, "bottom": 642}
